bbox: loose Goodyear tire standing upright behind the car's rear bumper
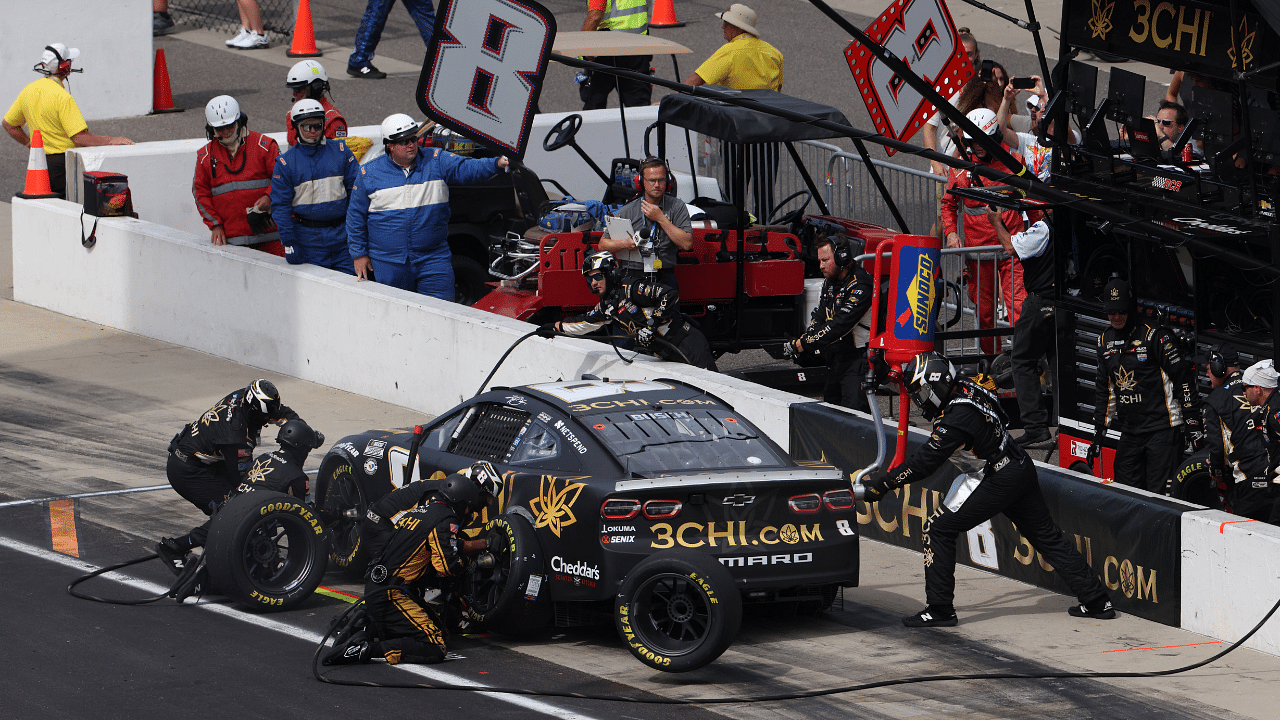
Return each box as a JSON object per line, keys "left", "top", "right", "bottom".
{"left": 613, "top": 550, "right": 742, "bottom": 673}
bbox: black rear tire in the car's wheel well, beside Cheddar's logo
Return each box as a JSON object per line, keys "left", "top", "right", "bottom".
{"left": 462, "top": 514, "right": 552, "bottom": 635}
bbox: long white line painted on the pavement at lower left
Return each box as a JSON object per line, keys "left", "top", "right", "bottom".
{"left": 0, "top": 532, "right": 596, "bottom": 720}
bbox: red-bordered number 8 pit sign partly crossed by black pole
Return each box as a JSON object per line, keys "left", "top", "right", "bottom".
{"left": 845, "top": 0, "right": 973, "bottom": 155}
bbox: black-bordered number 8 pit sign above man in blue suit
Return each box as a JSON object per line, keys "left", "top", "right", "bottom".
{"left": 417, "top": 0, "right": 556, "bottom": 160}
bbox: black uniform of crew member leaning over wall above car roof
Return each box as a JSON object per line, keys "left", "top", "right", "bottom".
{"left": 559, "top": 278, "right": 716, "bottom": 370}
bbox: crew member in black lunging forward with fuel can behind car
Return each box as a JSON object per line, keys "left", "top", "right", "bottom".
{"left": 865, "top": 351, "right": 1116, "bottom": 628}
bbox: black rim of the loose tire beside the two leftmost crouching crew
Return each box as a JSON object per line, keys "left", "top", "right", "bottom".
{"left": 241, "top": 515, "right": 315, "bottom": 594}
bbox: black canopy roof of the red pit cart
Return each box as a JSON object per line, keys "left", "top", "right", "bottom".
{"left": 658, "top": 85, "right": 849, "bottom": 145}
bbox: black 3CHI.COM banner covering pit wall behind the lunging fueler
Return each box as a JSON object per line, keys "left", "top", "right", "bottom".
{"left": 791, "top": 402, "right": 1189, "bottom": 626}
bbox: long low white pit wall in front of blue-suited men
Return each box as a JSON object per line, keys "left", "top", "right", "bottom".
{"left": 13, "top": 199, "right": 806, "bottom": 448}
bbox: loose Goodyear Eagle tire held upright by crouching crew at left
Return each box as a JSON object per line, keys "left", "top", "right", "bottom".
{"left": 205, "top": 492, "right": 328, "bottom": 612}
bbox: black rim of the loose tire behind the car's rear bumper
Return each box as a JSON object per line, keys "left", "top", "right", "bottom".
{"left": 631, "top": 573, "right": 713, "bottom": 656}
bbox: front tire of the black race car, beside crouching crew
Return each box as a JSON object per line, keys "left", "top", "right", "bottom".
{"left": 315, "top": 452, "right": 369, "bottom": 582}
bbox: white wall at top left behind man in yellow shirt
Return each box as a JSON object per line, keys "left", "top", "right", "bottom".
{"left": 0, "top": 0, "right": 152, "bottom": 120}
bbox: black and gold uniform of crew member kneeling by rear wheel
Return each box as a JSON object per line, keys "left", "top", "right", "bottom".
{"left": 364, "top": 474, "right": 463, "bottom": 665}
